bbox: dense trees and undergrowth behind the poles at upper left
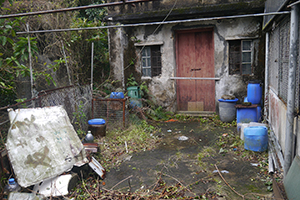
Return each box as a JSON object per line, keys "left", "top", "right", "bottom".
{"left": 0, "top": 0, "right": 109, "bottom": 107}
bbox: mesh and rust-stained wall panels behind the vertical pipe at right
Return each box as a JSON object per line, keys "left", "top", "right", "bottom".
{"left": 266, "top": 15, "right": 300, "bottom": 159}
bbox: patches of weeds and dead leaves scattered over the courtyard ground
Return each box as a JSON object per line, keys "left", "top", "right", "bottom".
{"left": 65, "top": 114, "right": 272, "bottom": 199}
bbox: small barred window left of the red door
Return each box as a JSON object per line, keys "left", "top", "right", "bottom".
{"left": 142, "top": 46, "right": 161, "bottom": 77}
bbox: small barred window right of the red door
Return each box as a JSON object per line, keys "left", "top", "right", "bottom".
{"left": 229, "top": 40, "right": 252, "bottom": 75}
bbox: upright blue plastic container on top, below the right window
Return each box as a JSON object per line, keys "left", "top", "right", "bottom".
{"left": 247, "top": 80, "right": 262, "bottom": 104}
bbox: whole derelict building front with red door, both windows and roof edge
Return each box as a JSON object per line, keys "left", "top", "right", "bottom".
{"left": 106, "top": 0, "right": 264, "bottom": 114}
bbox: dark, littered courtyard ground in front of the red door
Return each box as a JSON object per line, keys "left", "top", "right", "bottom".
{"left": 104, "top": 121, "right": 272, "bottom": 199}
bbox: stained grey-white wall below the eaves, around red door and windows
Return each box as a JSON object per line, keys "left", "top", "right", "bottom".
{"left": 109, "top": 17, "right": 264, "bottom": 111}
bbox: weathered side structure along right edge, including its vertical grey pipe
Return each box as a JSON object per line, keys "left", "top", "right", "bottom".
{"left": 263, "top": 0, "right": 300, "bottom": 175}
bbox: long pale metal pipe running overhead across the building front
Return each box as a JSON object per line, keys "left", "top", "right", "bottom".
{"left": 16, "top": 11, "right": 290, "bottom": 34}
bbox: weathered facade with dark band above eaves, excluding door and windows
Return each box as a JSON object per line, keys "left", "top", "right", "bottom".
{"left": 108, "top": 0, "right": 264, "bottom": 111}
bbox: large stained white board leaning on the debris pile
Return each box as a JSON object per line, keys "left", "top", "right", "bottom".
{"left": 6, "top": 106, "right": 88, "bottom": 187}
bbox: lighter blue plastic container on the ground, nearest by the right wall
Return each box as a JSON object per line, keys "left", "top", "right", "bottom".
{"left": 244, "top": 126, "right": 268, "bottom": 152}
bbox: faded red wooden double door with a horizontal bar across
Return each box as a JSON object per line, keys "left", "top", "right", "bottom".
{"left": 176, "top": 29, "right": 215, "bottom": 111}
